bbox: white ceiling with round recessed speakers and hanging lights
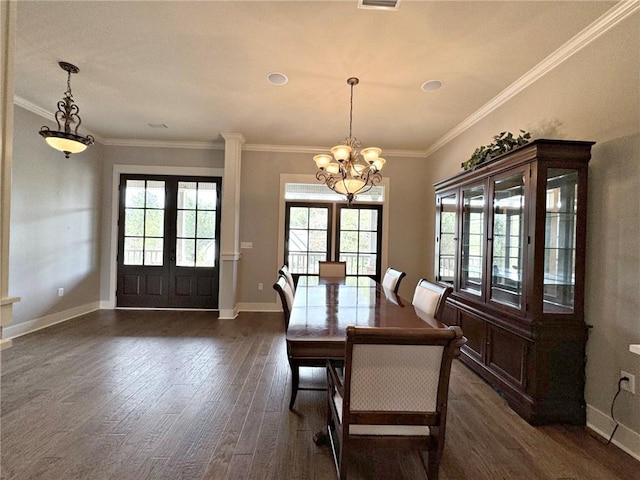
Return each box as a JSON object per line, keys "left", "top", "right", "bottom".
{"left": 15, "top": 0, "right": 616, "bottom": 153}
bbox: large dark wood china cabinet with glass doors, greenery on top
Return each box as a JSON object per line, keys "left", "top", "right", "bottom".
{"left": 435, "top": 140, "right": 594, "bottom": 424}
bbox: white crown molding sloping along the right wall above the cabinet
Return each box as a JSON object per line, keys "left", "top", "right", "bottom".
{"left": 423, "top": 0, "right": 640, "bottom": 157}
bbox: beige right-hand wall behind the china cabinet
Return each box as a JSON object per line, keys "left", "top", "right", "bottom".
{"left": 425, "top": 14, "right": 640, "bottom": 438}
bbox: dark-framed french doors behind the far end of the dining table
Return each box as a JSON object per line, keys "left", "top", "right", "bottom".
{"left": 284, "top": 202, "right": 382, "bottom": 281}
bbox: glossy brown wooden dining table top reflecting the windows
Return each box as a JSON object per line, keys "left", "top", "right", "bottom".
{"left": 286, "top": 276, "right": 447, "bottom": 358}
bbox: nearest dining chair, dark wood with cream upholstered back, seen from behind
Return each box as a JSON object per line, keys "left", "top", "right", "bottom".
{"left": 324, "top": 325, "right": 466, "bottom": 480}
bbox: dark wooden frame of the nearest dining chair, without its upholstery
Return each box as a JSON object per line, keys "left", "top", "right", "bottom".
{"left": 327, "top": 325, "right": 466, "bottom": 480}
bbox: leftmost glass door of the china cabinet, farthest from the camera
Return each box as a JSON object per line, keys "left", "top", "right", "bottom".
{"left": 436, "top": 193, "right": 458, "bottom": 285}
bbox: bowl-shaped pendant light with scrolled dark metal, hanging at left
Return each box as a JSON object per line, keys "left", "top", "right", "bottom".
{"left": 40, "top": 62, "right": 95, "bottom": 158}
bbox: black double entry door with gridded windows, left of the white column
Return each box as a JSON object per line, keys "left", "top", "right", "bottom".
{"left": 116, "top": 175, "right": 220, "bottom": 309}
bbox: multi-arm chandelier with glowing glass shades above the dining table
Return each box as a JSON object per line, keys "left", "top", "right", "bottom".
{"left": 313, "top": 77, "right": 386, "bottom": 206}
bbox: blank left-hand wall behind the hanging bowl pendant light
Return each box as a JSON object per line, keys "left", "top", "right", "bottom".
{"left": 9, "top": 106, "right": 102, "bottom": 330}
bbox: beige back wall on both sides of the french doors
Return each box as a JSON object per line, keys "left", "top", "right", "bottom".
{"left": 239, "top": 152, "right": 433, "bottom": 304}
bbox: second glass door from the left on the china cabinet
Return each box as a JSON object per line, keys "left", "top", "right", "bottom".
{"left": 460, "top": 185, "right": 485, "bottom": 295}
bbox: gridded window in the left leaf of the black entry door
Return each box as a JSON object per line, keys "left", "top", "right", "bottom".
{"left": 123, "top": 179, "right": 165, "bottom": 266}
